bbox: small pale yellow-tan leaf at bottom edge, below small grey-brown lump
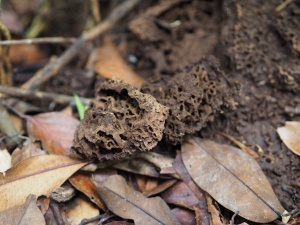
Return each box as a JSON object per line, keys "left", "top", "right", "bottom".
{"left": 66, "top": 195, "right": 99, "bottom": 225}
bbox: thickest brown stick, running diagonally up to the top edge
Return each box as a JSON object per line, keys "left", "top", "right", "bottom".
{"left": 23, "top": 0, "right": 140, "bottom": 90}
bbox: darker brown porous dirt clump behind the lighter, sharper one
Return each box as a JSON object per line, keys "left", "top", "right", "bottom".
{"left": 149, "top": 56, "right": 239, "bottom": 145}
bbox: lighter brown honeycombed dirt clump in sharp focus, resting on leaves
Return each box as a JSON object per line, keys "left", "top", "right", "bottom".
{"left": 74, "top": 80, "right": 169, "bottom": 161}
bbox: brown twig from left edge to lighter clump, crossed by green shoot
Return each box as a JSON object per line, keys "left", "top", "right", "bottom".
{"left": 0, "top": 85, "right": 91, "bottom": 105}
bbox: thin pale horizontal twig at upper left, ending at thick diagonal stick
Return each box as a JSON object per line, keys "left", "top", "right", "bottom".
{"left": 0, "top": 37, "right": 76, "bottom": 46}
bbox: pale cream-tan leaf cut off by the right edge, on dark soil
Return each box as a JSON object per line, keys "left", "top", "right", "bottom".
{"left": 277, "top": 121, "right": 300, "bottom": 155}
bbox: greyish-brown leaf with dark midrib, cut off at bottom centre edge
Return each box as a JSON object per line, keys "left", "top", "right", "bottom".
{"left": 95, "top": 175, "right": 179, "bottom": 225}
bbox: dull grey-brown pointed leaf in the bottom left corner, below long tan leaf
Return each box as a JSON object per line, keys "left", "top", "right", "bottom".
{"left": 0, "top": 195, "right": 46, "bottom": 225}
